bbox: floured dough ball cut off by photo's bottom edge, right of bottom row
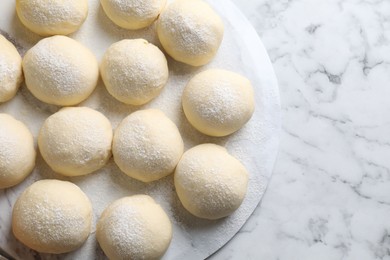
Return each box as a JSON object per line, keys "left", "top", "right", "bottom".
{"left": 96, "top": 195, "right": 172, "bottom": 260}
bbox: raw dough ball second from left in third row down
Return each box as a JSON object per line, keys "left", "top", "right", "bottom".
{"left": 38, "top": 107, "right": 112, "bottom": 176}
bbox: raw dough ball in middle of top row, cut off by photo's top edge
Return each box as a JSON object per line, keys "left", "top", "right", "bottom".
{"left": 100, "top": 0, "right": 167, "bottom": 30}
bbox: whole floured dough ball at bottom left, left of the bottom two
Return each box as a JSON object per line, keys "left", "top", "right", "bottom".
{"left": 12, "top": 180, "right": 92, "bottom": 254}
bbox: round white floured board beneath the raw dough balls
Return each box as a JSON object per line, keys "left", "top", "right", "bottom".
{"left": 0, "top": 0, "right": 280, "bottom": 260}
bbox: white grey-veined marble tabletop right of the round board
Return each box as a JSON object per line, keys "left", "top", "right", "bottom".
{"left": 212, "top": 0, "right": 390, "bottom": 260}
